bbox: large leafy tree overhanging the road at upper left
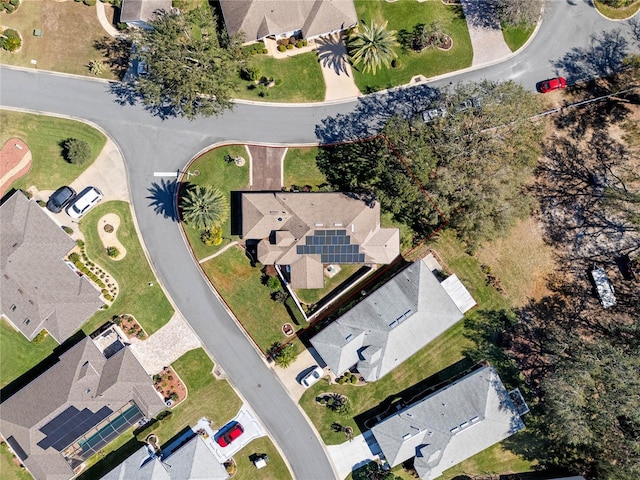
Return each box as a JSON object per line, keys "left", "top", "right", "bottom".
{"left": 133, "top": 7, "right": 242, "bottom": 118}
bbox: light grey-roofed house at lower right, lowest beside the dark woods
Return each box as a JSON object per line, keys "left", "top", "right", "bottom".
{"left": 371, "top": 366, "right": 524, "bottom": 480}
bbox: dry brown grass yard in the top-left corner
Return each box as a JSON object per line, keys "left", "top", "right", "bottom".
{"left": 0, "top": 0, "right": 115, "bottom": 78}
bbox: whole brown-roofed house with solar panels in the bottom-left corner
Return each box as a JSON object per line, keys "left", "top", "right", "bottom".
{"left": 0, "top": 337, "right": 165, "bottom": 480}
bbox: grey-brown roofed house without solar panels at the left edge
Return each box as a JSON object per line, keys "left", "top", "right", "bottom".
{"left": 0, "top": 191, "right": 103, "bottom": 342}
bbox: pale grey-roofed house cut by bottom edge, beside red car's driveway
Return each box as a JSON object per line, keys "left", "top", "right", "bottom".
{"left": 101, "top": 434, "right": 229, "bottom": 480}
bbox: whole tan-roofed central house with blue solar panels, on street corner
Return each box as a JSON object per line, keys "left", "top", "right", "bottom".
{"left": 241, "top": 192, "right": 400, "bottom": 288}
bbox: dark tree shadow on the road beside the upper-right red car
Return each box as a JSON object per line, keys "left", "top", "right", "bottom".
{"left": 551, "top": 29, "right": 629, "bottom": 83}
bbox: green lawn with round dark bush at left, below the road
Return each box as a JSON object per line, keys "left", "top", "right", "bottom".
{"left": 0, "top": 110, "right": 107, "bottom": 190}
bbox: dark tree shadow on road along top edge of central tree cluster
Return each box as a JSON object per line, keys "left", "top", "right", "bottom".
{"left": 315, "top": 85, "right": 441, "bottom": 145}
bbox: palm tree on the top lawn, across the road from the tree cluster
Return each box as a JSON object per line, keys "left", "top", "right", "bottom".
{"left": 349, "top": 20, "right": 398, "bottom": 75}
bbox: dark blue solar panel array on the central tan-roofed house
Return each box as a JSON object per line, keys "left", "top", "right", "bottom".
{"left": 296, "top": 230, "right": 364, "bottom": 263}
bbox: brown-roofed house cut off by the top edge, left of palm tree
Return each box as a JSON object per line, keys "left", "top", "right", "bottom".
{"left": 219, "top": 0, "right": 358, "bottom": 41}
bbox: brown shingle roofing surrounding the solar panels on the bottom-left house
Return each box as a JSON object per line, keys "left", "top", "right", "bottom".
{"left": 0, "top": 338, "right": 165, "bottom": 480}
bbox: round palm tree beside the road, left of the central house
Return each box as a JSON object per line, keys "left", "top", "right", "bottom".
{"left": 180, "top": 185, "right": 229, "bottom": 230}
